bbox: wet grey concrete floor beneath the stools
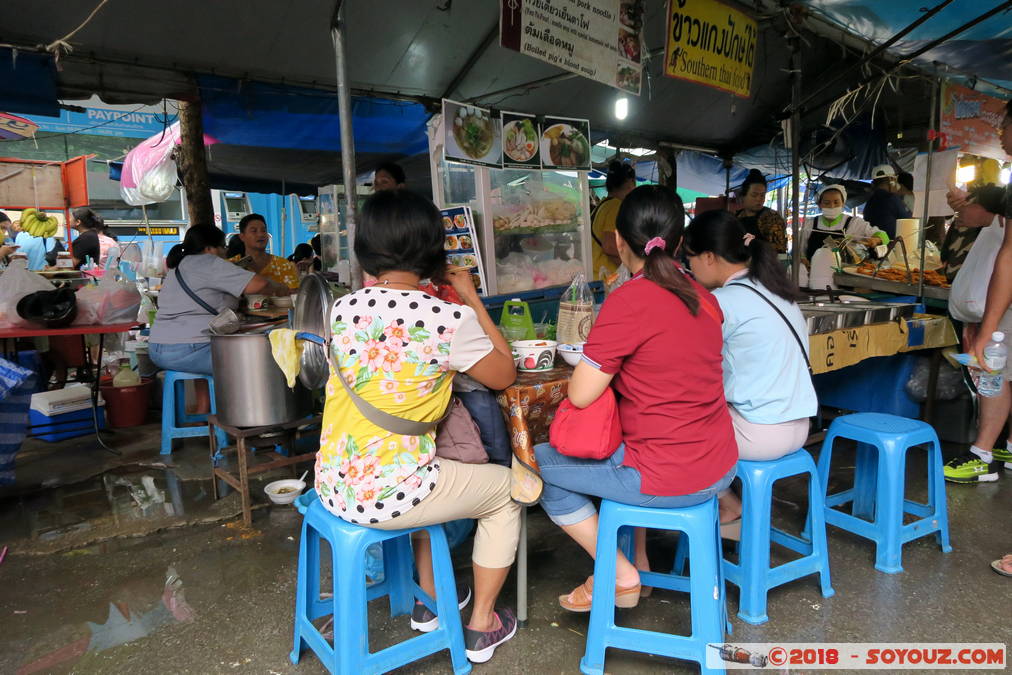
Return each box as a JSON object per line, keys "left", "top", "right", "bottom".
{"left": 0, "top": 427, "right": 1012, "bottom": 674}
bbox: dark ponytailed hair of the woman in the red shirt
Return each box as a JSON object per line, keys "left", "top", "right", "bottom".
{"left": 615, "top": 185, "right": 699, "bottom": 316}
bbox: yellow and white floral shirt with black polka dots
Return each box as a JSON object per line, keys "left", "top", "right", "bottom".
{"left": 316, "top": 286, "right": 492, "bottom": 523}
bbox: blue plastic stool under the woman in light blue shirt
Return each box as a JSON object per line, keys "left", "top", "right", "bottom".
{"left": 720, "top": 449, "right": 834, "bottom": 623}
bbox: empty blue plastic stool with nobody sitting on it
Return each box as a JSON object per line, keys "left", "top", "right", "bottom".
{"left": 819, "top": 413, "right": 952, "bottom": 574}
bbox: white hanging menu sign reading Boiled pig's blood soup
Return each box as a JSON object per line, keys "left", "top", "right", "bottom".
{"left": 499, "top": 0, "right": 643, "bottom": 95}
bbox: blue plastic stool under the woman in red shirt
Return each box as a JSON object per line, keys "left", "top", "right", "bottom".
{"left": 580, "top": 498, "right": 727, "bottom": 674}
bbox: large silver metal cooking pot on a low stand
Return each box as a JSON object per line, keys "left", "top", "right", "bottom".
{"left": 210, "top": 334, "right": 312, "bottom": 427}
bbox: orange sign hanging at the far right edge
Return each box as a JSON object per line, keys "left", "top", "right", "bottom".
{"left": 940, "top": 82, "right": 1005, "bottom": 161}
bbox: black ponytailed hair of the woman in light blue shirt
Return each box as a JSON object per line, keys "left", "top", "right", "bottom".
{"left": 685, "top": 210, "right": 805, "bottom": 303}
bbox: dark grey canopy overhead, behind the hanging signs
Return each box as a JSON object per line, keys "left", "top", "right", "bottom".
{"left": 0, "top": 0, "right": 926, "bottom": 155}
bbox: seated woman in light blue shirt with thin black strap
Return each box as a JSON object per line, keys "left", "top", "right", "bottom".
{"left": 684, "top": 210, "right": 819, "bottom": 535}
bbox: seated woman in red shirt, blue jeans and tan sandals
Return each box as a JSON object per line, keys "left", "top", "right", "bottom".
{"left": 534, "top": 185, "right": 738, "bottom": 611}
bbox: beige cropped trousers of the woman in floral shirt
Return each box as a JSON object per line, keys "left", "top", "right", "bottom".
{"left": 366, "top": 457, "right": 520, "bottom": 568}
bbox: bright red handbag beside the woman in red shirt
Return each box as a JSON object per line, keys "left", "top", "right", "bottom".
{"left": 549, "top": 387, "right": 622, "bottom": 459}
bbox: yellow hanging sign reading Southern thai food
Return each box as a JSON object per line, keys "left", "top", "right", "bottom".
{"left": 664, "top": 0, "right": 759, "bottom": 98}
